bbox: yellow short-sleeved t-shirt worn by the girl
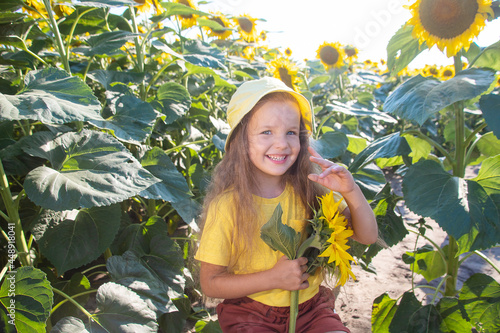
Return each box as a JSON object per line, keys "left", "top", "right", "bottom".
{"left": 195, "top": 185, "right": 347, "bottom": 306}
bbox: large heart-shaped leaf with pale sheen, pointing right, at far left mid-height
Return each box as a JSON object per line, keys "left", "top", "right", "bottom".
{"left": 23, "top": 130, "right": 160, "bottom": 211}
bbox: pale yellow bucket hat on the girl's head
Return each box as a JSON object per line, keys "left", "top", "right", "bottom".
{"left": 225, "top": 77, "right": 313, "bottom": 150}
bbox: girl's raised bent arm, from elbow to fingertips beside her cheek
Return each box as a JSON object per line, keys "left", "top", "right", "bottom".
{"left": 309, "top": 147, "right": 378, "bottom": 244}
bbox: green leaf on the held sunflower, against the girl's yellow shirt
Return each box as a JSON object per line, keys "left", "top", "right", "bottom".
{"left": 260, "top": 204, "right": 300, "bottom": 259}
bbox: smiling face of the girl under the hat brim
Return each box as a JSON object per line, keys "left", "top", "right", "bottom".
{"left": 248, "top": 100, "right": 300, "bottom": 186}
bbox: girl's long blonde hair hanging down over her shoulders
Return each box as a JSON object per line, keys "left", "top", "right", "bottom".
{"left": 201, "top": 92, "right": 325, "bottom": 270}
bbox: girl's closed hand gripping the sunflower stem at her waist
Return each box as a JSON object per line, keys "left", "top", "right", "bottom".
{"left": 271, "top": 256, "right": 309, "bottom": 290}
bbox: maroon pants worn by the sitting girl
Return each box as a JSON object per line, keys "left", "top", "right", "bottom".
{"left": 217, "top": 287, "right": 350, "bottom": 333}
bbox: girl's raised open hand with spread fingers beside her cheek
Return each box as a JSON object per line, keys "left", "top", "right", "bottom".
{"left": 308, "top": 147, "right": 356, "bottom": 195}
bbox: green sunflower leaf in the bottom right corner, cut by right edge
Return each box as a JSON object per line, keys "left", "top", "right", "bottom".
{"left": 458, "top": 273, "right": 500, "bottom": 332}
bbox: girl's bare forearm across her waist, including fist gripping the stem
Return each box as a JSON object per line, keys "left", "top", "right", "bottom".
{"left": 200, "top": 256, "right": 309, "bottom": 299}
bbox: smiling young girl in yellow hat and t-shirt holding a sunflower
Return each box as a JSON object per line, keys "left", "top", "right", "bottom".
{"left": 195, "top": 78, "right": 378, "bottom": 333}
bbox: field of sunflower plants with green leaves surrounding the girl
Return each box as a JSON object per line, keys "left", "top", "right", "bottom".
{"left": 0, "top": 0, "right": 500, "bottom": 333}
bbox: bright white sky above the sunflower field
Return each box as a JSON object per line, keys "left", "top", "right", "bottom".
{"left": 199, "top": 0, "right": 500, "bottom": 68}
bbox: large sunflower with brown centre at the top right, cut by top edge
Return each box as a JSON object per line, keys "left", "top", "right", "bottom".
{"left": 407, "top": 0, "right": 494, "bottom": 57}
